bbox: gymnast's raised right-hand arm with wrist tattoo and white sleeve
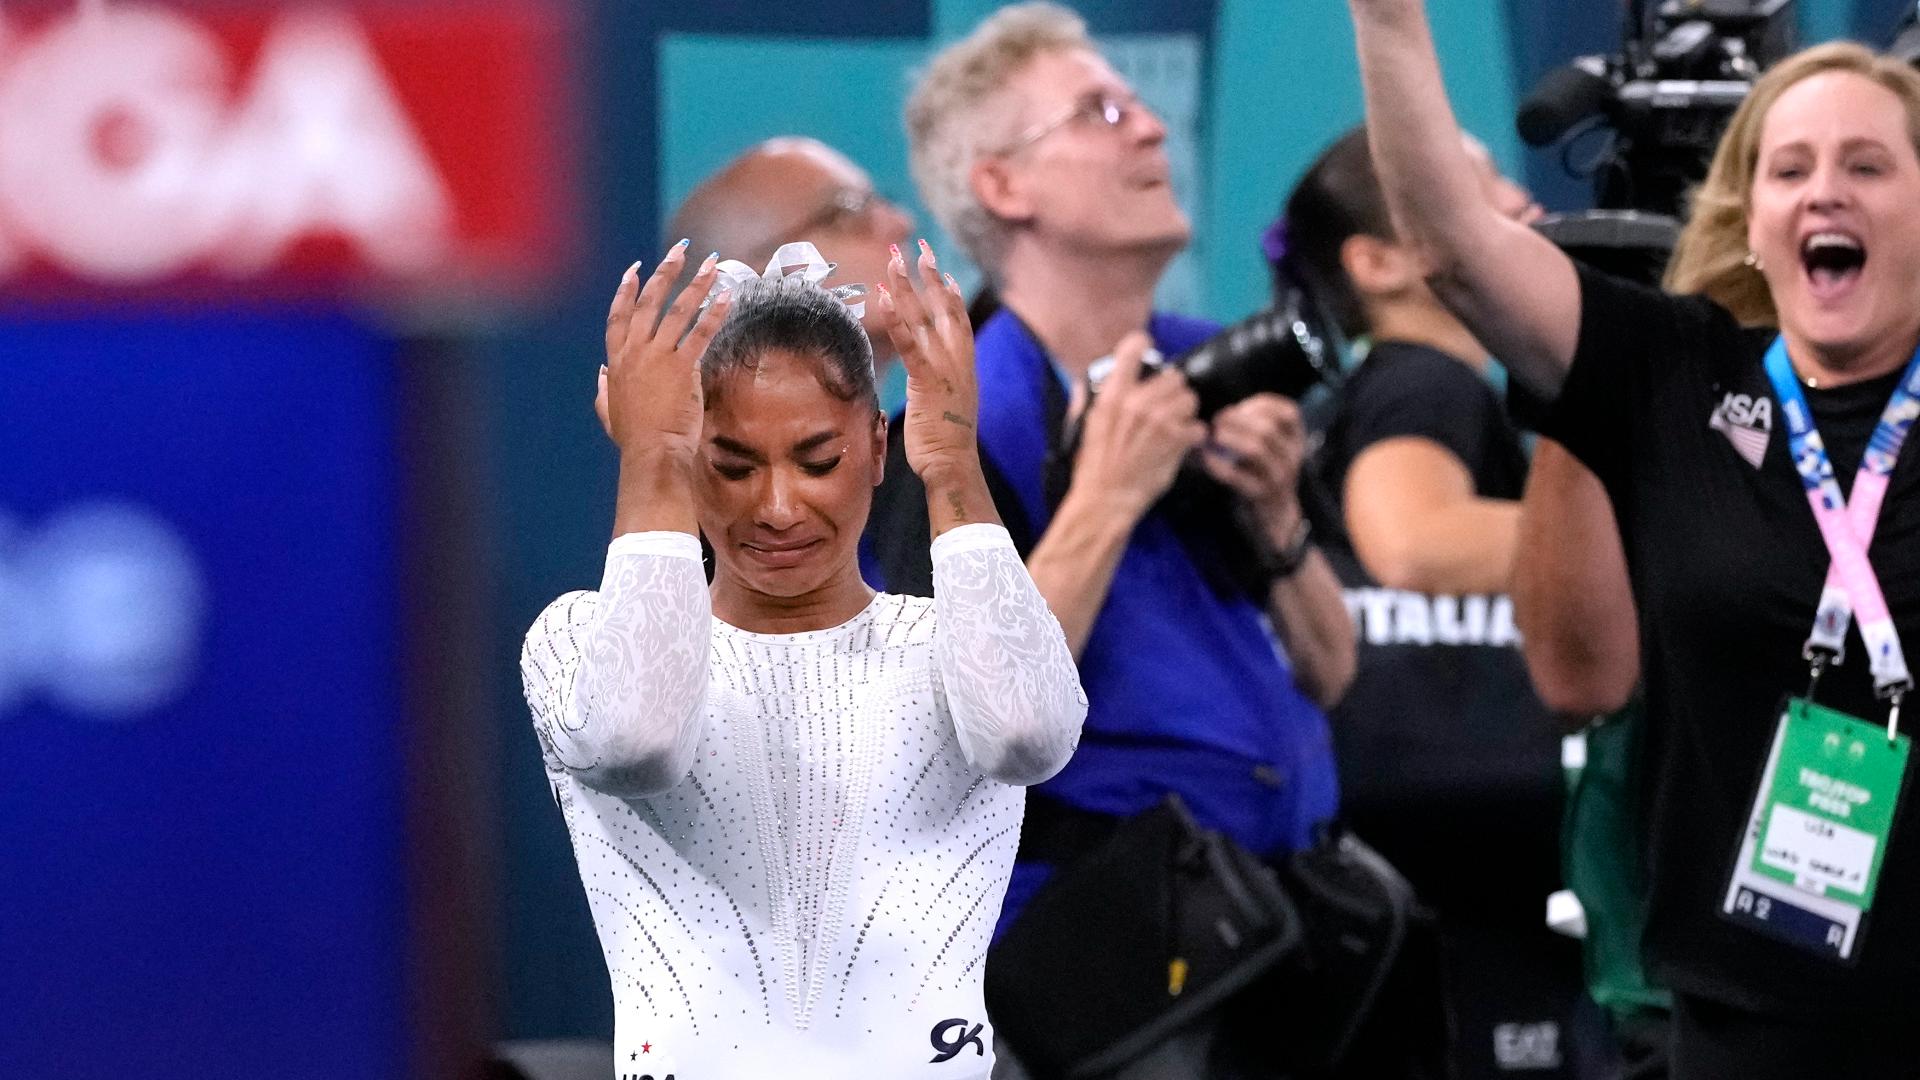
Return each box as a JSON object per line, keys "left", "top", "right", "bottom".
{"left": 881, "top": 242, "right": 1087, "bottom": 784}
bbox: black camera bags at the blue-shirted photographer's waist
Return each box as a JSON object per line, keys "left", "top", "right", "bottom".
{"left": 985, "top": 796, "right": 1444, "bottom": 1080}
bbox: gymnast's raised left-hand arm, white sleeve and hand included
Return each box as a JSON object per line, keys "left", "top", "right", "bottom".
{"left": 520, "top": 242, "right": 732, "bottom": 796}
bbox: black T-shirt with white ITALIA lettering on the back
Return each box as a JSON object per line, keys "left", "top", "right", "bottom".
{"left": 1319, "top": 342, "right": 1563, "bottom": 907}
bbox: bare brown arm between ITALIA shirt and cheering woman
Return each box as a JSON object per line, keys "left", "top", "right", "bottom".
{"left": 1513, "top": 438, "right": 1640, "bottom": 728}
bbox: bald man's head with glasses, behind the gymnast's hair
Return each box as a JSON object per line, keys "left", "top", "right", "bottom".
{"left": 664, "top": 136, "right": 914, "bottom": 357}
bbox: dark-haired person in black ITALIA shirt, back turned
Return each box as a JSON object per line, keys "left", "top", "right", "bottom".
{"left": 1265, "top": 127, "right": 1599, "bottom": 1080}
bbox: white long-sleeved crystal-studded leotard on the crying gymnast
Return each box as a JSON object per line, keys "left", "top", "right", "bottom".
{"left": 522, "top": 525, "right": 1087, "bottom": 1080}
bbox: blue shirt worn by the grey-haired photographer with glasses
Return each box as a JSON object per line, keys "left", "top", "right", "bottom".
{"left": 975, "top": 311, "right": 1338, "bottom": 926}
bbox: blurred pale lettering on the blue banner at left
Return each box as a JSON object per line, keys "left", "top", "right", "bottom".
{"left": 0, "top": 502, "right": 205, "bottom": 719}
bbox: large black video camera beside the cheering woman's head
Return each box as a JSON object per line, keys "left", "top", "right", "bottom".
{"left": 1519, "top": 0, "right": 1793, "bottom": 215}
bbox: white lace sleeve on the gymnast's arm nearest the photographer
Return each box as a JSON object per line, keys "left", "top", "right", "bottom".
{"left": 933, "top": 525, "right": 1087, "bottom": 784}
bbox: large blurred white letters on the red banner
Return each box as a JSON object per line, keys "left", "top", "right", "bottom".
{"left": 0, "top": 4, "right": 453, "bottom": 282}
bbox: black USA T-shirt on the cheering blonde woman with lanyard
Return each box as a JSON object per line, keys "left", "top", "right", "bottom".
{"left": 1546, "top": 267, "right": 1920, "bottom": 1017}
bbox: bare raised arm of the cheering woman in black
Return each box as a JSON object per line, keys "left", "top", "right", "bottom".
{"left": 1348, "top": 0, "right": 1580, "bottom": 394}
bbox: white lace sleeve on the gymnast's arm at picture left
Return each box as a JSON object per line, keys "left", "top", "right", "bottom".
{"left": 520, "top": 532, "right": 712, "bottom": 796}
